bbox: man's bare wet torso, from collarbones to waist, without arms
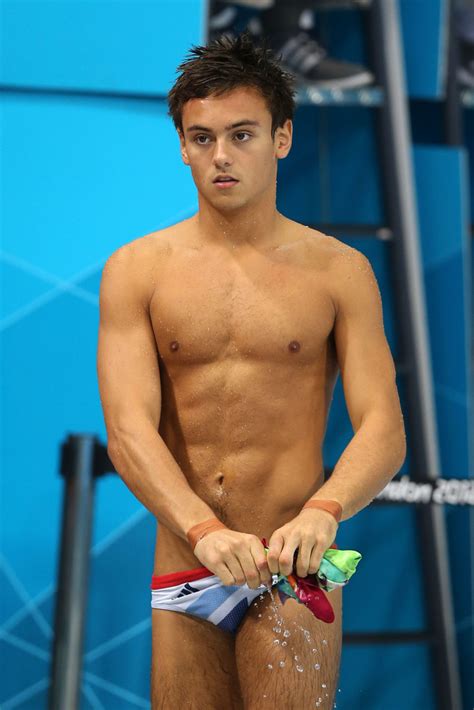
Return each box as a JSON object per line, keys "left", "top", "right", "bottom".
{"left": 150, "top": 220, "right": 341, "bottom": 574}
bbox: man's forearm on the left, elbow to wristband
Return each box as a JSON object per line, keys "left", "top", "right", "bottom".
{"left": 108, "top": 421, "right": 215, "bottom": 540}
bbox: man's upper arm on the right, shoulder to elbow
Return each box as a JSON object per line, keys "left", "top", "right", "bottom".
{"left": 334, "top": 248, "right": 400, "bottom": 430}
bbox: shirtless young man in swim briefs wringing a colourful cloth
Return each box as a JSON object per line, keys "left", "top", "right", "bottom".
{"left": 98, "top": 37, "right": 405, "bottom": 710}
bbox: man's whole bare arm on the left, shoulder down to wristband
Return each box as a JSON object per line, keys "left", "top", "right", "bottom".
{"left": 97, "top": 242, "right": 215, "bottom": 540}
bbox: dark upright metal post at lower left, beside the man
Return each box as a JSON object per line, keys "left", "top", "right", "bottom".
{"left": 49, "top": 434, "right": 96, "bottom": 710}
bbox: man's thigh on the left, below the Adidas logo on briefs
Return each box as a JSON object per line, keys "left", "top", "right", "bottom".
{"left": 151, "top": 609, "right": 243, "bottom": 710}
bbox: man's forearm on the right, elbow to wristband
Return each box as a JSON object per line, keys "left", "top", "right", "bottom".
{"left": 312, "top": 415, "right": 406, "bottom": 520}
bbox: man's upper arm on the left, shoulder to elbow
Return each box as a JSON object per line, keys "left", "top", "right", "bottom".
{"left": 97, "top": 247, "right": 161, "bottom": 442}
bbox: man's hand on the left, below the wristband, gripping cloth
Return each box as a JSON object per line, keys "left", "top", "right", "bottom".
{"left": 194, "top": 530, "right": 271, "bottom": 589}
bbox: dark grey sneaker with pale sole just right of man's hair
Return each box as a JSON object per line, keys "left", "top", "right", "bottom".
{"left": 270, "top": 32, "right": 375, "bottom": 89}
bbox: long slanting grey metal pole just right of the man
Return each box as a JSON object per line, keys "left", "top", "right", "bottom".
{"left": 372, "top": 0, "right": 462, "bottom": 710}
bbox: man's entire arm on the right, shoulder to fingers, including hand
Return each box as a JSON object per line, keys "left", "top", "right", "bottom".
{"left": 267, "top": 246, "right": 406, "bottom": 577}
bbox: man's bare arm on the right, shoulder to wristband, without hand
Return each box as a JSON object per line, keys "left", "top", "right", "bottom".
{"left": 312, "top": 247, "right": 406, "bottom": 520}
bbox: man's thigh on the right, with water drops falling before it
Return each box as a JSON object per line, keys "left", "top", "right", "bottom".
{"left": 235, "top": 589, "right": 342, "bottom": 710}
